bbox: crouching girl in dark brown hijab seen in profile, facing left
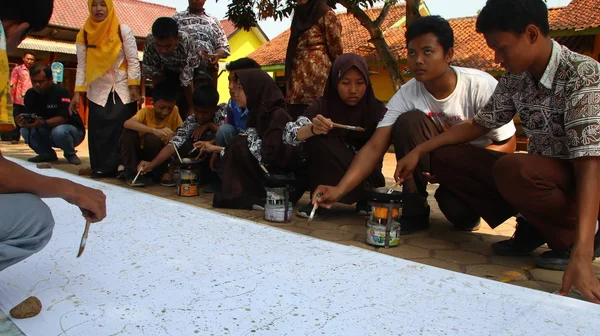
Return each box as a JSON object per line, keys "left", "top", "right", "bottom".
{"left": 212, "top": 69, "right": 304, "bottom": 209}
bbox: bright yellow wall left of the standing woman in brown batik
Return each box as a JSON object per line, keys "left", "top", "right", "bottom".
{"left": 217, "top": 30, "right": 262, "bottom": 103}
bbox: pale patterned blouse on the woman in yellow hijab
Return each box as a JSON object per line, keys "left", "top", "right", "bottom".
{"left": 75, "top": 24, "right": 141, "bottom": 107}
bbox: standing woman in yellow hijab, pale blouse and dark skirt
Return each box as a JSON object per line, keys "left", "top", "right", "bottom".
{"left": 70, "top": 0, "right": 141, "bottom": 178}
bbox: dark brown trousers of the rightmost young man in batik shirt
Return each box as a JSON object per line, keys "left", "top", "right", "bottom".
{"left": 431, "top": 145, "right": 596, "bottom": 250}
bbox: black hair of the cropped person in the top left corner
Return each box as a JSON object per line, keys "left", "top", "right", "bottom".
{"left": 0, "top": 0, "right": 54, "bottom": 31}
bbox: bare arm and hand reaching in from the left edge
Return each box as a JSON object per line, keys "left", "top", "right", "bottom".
{"left": 0, "top": 153, "right": 106, "bottom": 222}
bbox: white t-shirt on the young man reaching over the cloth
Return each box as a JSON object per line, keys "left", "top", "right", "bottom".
{"left": 377, "top": 67, "right": 516, "bottom": 147}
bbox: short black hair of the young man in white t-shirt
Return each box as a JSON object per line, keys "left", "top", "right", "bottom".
{"left": 404, "top": 15, "right": 454, "bottom": 53}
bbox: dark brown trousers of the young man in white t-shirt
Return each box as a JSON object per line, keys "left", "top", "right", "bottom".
{"left": 392, "top": 111, "right": 480, "bottom": 227}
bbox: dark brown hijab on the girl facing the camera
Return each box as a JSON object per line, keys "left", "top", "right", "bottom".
{"left": 304, "top": 54, "right": 386, "bottom": 147}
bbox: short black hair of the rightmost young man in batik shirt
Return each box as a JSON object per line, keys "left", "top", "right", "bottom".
{"left": 475, "top": 0, "right": 550, "bottom": 36}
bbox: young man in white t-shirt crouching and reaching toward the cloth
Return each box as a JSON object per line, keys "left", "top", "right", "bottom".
{"left": 314, "top": 16, "right": 516, "bottom": 234}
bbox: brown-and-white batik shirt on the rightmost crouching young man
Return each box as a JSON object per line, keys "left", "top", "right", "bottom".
{"left": 474, "top": 41, "right": 600, "bottom": 159}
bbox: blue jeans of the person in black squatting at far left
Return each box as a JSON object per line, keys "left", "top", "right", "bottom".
{"left": 21, "top": 124, "right": 85, "bottom": 157}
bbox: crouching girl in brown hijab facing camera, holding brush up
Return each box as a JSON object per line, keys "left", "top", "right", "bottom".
{"left": 284, "top": 54, "right": 386, "bottom": 217}
